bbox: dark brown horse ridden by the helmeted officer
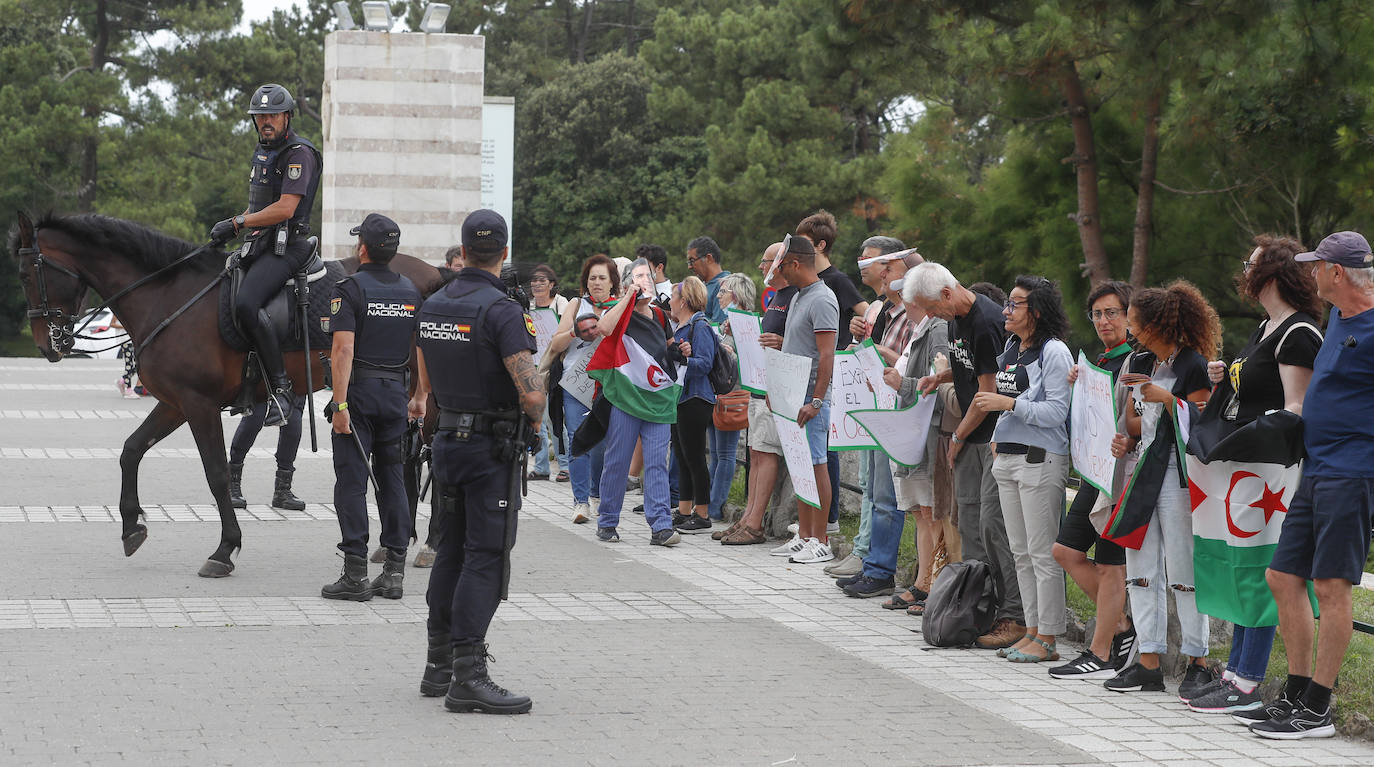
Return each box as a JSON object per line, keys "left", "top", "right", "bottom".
{"left": 10, "top": 213, "right": 442, "bottom": 577}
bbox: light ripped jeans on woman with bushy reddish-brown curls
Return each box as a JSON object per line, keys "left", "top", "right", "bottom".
{"left": 1125, "top": 458, "right": 1208, "bottom": 657}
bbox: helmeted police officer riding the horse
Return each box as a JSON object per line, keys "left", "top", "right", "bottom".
{"left": 210, "top": 84, "right": 320, "bottom": 426}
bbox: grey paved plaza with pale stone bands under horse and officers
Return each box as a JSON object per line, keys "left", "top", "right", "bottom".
{"left": 0, "top": 359, "right": 1374, "bottom": 767}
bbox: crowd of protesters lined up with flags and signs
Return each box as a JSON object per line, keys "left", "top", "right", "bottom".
{"left": 529, "top": 212, "right": 1374, "bottom": 738}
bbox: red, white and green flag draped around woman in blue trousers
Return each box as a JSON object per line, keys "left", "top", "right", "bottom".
{"left": 587, "top": 307, "right": 682, "bottom": 423}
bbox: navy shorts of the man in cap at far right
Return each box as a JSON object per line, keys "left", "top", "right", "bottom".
{"left": 1270, "top": 474, "right": 1374, "bottom": 583}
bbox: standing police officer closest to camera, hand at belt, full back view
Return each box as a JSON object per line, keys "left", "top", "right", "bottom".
{"left": 411, "top": 210, "right": 544, "bottom": 713}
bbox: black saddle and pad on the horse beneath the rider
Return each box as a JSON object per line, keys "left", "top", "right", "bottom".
{"left": 220, "top": 236, "right": 345, "bottom": 352}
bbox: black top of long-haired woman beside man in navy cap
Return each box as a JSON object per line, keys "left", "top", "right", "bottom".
{"left": 1219, "top": 312, "right": 1322, "bottom": 423}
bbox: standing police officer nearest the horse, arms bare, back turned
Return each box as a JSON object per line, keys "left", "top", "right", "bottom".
{"left": 320, "top": 213, "right": 420, "bottom": 602}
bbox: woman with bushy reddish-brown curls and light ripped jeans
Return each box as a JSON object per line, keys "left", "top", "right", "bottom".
{"left": 1103, "top": 280, "right": 1221, "bottom": 700}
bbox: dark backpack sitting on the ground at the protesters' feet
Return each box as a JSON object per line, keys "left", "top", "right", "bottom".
{"left": 921, "top": 559, "right": 998, "bottom": 647}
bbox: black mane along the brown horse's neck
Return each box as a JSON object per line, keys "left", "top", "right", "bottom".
{"left": 30, "top": 213, "right": 224, "bottom": 272}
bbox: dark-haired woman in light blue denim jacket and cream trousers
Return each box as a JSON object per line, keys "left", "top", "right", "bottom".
{"left": 973, "top": 275, "right": 1073, "bottom": 663}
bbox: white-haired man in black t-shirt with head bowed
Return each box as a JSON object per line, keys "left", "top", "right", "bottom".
{"left": 901, "top": 261, "right": 1026, "bottom": 650}
